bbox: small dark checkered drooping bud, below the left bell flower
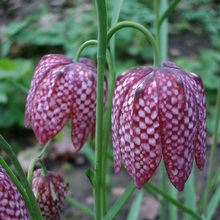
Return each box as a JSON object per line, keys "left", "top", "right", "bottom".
{"left": 32, "top": 169, "right": 68, "bottom": 220}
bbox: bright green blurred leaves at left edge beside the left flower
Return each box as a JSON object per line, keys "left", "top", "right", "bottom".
{"left": 0, "top": 58, "right": 33, "bottom": 128}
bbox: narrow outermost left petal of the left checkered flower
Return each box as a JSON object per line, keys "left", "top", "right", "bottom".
{"left": 25, "top": 54, "right": 73, "bottom": 127}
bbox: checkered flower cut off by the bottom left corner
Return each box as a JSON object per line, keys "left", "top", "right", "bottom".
{"left": 0, "top": 166, "right": 30, "bottom": 220}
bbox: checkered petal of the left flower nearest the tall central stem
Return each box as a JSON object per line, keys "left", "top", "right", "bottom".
{"left": 71, "top": 63, "right": 96, "bottom": 150}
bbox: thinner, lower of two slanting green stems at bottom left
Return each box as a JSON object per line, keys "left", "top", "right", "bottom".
{"left": 0, "top": 156, "right": 35, "bottom": 217}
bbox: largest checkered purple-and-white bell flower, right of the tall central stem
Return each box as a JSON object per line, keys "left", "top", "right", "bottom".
{"left": 112, "top": 62, "right": 206, "bottom": 190}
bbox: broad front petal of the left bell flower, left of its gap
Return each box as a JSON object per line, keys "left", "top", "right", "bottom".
{"left": 31, "top": 64, "right": 74, "bottom": 144}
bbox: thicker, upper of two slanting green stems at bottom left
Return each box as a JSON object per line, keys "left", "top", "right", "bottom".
{"left": 0, "top": 135, "right": 42, "bottom": 220}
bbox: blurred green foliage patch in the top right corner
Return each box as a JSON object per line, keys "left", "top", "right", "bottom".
{"left": 171, "top": 0, "right": 220, "bottom": 50}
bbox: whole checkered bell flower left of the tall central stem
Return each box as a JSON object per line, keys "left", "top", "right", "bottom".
{"left": 25, "top": 54, "right": 107, "bottom": 150}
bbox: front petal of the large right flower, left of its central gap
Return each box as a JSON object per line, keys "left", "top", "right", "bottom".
{"left": 130, "top": 74, "right": 162, "bottom": 188}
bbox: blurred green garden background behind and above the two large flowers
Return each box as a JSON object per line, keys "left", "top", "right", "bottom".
{"left": 0, "top": 0, "right": 220, "bottom": 134}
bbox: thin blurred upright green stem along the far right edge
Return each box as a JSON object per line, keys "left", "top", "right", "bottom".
{"left": 203, "top": 80, "right": 220, "bottom": 213}
